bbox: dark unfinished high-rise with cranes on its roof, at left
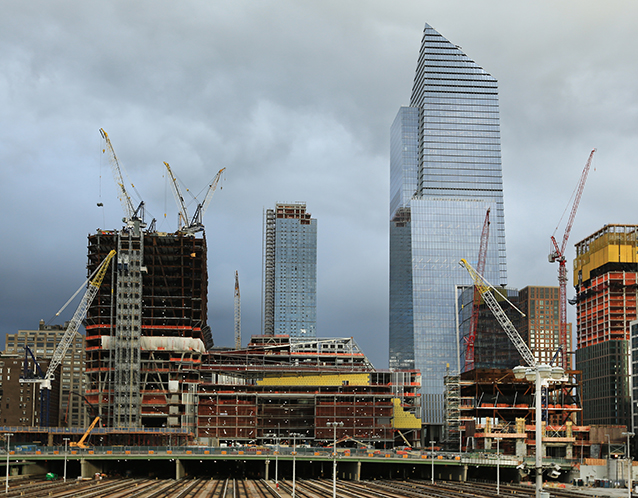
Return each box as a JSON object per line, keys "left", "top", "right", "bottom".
{"left": 85, "top": 227, "right": 213, "bottom": 429}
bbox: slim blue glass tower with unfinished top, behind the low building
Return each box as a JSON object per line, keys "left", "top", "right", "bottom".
{"left": 264, "top": 203, "right": 317, "bottom": 338}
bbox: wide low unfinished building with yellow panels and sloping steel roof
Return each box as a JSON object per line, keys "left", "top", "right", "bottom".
{"left": 197, "top": 336, "right": 421, "bottom": 448}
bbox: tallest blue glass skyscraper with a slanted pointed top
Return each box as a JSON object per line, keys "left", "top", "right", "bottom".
{"left": 390, "top": 24, "right": 507, "bottom": 425}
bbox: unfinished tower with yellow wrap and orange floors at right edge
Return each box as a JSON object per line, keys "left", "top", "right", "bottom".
{"left": 574, "top": 225, "right": 638, "bottom": 427}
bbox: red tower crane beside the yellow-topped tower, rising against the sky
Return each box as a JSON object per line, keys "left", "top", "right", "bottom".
{"left": 549, "top": 149, "right": 596, "bottom": 369}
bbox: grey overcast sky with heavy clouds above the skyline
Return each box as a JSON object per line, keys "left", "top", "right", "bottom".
{"left": 0, "top": 0, "right": 638, "bottom": 368}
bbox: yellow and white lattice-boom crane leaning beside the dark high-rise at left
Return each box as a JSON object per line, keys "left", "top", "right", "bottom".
{"left": 20, "top": 250, "right": 115, "bottom": 427}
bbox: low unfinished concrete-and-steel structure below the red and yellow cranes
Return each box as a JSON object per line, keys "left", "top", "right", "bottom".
{"left": 446, "top": 369, "right": 590, "bottom": 458}
